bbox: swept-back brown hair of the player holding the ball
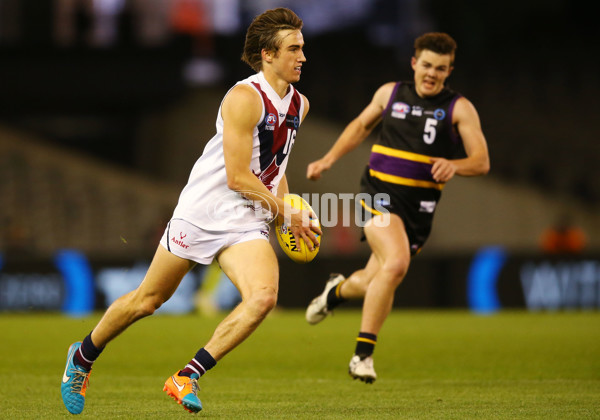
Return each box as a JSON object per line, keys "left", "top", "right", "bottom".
{"left": 242, "top": 7, "right": 303, "bottom": 72}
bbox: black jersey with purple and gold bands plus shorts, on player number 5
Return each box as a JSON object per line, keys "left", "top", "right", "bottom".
{"left": 361, "top": 82, "right": 463, "bottom": 254}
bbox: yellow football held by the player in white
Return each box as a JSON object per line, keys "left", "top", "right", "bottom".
{"left": 275, "top": 194, "right": 321, "bottom": 264}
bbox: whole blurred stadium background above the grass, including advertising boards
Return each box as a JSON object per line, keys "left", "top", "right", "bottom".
{"left": 0, "top": 0, "right": 600, "bottom": 314}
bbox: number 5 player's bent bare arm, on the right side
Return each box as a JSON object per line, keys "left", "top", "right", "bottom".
{"left": 431, "top": 98, "right": 490, "bottom": 182}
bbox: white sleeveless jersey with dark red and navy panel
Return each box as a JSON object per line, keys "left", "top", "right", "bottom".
{"left": 173, "top": 72, "right": 304, "bottom": 232}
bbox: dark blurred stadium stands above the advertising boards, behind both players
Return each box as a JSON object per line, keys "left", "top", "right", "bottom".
{"left": 0, "top": 0, "right": 600, "bottom": 257}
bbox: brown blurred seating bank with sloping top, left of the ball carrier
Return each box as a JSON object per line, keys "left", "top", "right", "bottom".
{"left": 0, "top": 127, "right": 179, "bottom": 260}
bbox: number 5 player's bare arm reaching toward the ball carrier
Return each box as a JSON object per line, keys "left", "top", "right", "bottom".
{"left": 306, "top": 82, "right": 395, "bottom": 180}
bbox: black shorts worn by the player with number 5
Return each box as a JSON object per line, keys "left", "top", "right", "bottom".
{"left": 360, "top": 167, "right": 441, "bottom": 255}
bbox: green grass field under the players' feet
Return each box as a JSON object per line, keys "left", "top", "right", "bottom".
{"left": 0, "top": 310, "right": 600, "bottom": 419}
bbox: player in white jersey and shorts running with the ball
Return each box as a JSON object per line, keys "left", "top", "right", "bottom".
{"left": 61, "top": 8, "right": 321, "bottom": 414}
